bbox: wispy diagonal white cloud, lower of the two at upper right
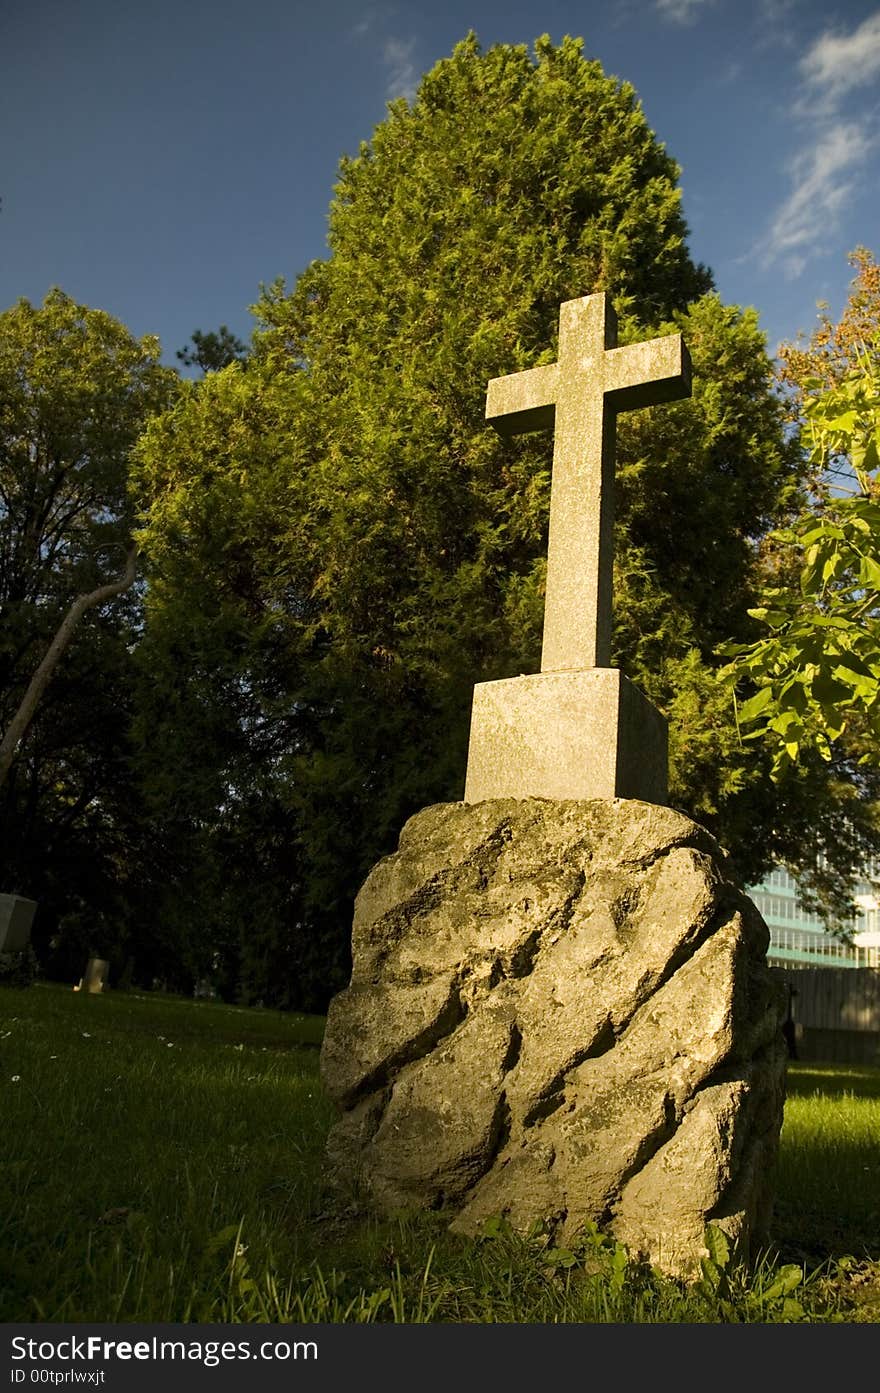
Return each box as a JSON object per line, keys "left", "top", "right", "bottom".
{"left": 762, "top": 121, "right": 877, "bottom": 279}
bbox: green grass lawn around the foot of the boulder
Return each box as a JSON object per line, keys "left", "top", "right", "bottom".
{"left": 0, "top": 983, "right": 880, "bottom": 1322}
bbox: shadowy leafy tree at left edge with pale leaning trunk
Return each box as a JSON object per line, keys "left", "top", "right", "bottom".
{"left": 0, "top": 290, "right": 177, "bottom": 970}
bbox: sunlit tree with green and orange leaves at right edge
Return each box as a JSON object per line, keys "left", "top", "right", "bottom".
{"left": 720, "top": 247, "right": 880, "bottom": 928}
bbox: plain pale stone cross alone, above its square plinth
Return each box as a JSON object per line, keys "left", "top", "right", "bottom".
{"left": 486, "top": 294, "right": 691, "bottom": 673}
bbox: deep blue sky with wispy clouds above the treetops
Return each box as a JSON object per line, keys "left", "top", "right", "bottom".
{"left": 0, "top": 0, "right": 880, "bottom": 362}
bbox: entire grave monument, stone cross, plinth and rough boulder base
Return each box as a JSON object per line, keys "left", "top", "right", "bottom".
{"left": 320, "top": 295, "right": 785, "bottom": 1275}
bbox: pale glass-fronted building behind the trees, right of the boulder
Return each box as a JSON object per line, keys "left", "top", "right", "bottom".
{"left": 748, "top": 866, "right": 880, "bottom": 967}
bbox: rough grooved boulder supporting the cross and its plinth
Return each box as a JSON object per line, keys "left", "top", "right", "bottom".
{"left": 322, "top": 798, "right": 785, "bottom": 1275}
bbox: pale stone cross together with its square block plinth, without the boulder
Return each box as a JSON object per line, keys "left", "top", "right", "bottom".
{"left": 465, "top": 295, "right": 691, "bottom": 804}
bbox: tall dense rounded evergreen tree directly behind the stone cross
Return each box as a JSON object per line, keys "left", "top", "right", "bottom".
{"left": 132, "top": 35, "right": 837, "bottom": 991}
